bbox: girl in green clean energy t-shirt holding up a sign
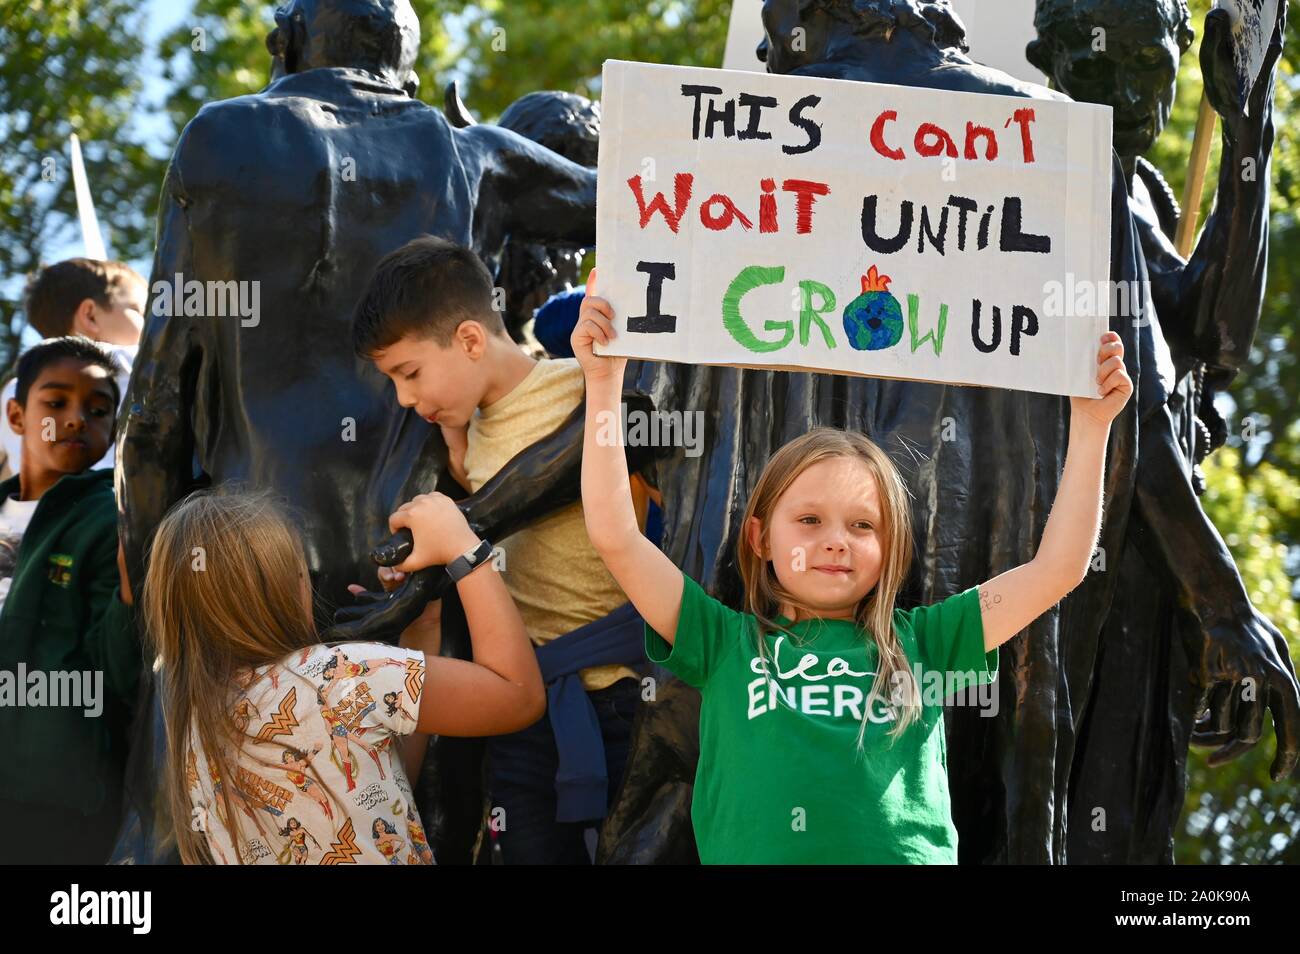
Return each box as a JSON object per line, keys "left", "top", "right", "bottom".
{"left": 572, "top": 272, "right": 1132, "bottom": 863}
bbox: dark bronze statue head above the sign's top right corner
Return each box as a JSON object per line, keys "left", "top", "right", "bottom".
{"left": 1024, "top": 0, "right": 1193, "bottom": 157}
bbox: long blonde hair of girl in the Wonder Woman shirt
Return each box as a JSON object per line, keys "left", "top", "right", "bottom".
{"left": 140, "top": 487, "right": 317, "bottom": 864}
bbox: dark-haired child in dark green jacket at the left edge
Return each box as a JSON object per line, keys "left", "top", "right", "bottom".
{"left": 0, "top": 337, "right": 140, "bottom": 864}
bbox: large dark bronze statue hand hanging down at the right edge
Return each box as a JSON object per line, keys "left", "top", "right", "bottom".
{"left": 1191, "top": 607, "right": 1300, "bottom": 781}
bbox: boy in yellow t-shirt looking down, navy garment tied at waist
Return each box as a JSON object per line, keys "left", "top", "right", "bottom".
{"left": 352, "top": 235, "right": 644, "bottom": 864}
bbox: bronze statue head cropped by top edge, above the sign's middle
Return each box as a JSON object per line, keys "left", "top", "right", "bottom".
{"left": 757, "top": 0, "right": 969, "bottom": 73}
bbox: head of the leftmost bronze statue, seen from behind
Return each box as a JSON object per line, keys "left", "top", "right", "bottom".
{"left": 267, "top": 0, "right": 420, "bottom": 95}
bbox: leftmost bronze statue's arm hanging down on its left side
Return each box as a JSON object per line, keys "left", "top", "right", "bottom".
{"left": 114, "top": 154, "right": 204, "bottom": 593}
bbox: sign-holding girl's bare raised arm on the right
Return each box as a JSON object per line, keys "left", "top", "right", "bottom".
{"left": 979, "top": 331, "right": 1134, "bottom": 651}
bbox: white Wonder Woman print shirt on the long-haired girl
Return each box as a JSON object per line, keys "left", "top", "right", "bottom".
{"left": 186, "top": 643, "right": 434, "bottom": 864}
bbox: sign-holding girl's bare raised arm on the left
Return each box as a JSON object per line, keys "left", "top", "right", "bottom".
{"left": 571, "top": 269, "right": 683, "bottom": 643}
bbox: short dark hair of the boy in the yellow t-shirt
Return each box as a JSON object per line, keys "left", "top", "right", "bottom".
{"left": 352, "top": 235, "right": 506, "bottom": 360}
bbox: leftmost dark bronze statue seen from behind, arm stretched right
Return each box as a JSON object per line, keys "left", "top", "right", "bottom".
{"left": 117, "top": 0, "right": 655, "bottom": 860}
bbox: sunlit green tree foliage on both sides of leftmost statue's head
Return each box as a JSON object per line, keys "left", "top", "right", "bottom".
{"left": 0, "top": 0, "right": 731, "bottom": 332}
